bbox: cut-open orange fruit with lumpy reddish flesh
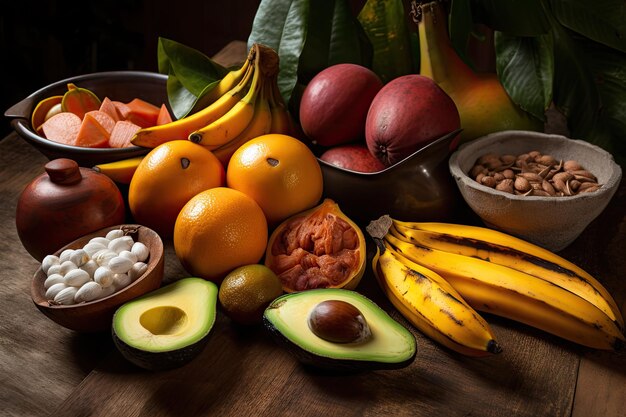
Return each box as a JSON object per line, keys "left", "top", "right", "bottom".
{"left": 265, "top": 199, "right": 366, "bottom": 292}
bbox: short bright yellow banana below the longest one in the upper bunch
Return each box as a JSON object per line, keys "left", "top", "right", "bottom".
{"left": 189, "top": 46, "right": 265, "bottom": 150}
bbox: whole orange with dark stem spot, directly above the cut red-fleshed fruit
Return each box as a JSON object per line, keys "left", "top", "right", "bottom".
{"left": 226, "top": 134, "right": 323, "bottom": 226}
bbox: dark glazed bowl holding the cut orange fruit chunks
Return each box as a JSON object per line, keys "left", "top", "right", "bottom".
{"left": 4, "top": 71, "right": 167, "bottom": 167}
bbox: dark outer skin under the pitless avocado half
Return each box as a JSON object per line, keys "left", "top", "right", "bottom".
{"left": 111, "top": 324, "right": 211, "bottom": 371}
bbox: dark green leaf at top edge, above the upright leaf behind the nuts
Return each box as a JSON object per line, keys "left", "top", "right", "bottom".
{"left": 472, "top": 0, "right": 558, "bottom": 36}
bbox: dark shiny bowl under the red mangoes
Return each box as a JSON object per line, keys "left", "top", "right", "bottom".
{"left": 318, "top": 131, "right": 462, "bottom": 226}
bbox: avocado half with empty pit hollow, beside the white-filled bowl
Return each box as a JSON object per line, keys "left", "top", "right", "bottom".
{"left": 112, "top": 278, "right": 218, "bottom": 371}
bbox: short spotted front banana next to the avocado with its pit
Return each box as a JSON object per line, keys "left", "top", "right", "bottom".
{"left": 372, "top": 244, "right": 501, "bottom": 357}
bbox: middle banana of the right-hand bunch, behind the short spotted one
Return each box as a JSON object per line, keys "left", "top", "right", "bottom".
{"left": 384, "top": 226, "right": 625, "bottom": 350}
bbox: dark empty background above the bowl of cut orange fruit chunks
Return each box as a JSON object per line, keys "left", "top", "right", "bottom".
{"left": 0, "top": 0, "right": 260, "bottom": 137}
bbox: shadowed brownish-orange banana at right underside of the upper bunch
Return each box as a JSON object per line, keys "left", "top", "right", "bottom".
{"left": 213, "top": 78, "right": 274, "bottom": 167}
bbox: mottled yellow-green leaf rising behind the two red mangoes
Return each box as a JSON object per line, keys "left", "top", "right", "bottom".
{"left": 358, "top": 0, "right": 415, "bottom": 83}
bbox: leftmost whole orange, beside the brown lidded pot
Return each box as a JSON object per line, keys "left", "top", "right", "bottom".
{"left": 128, "top": 140, "right": 225, "bottom": 238}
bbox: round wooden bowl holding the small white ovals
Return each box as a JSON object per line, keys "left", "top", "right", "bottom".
{"left": 31, "top": 224, "right": 164, "bottom": 332}
